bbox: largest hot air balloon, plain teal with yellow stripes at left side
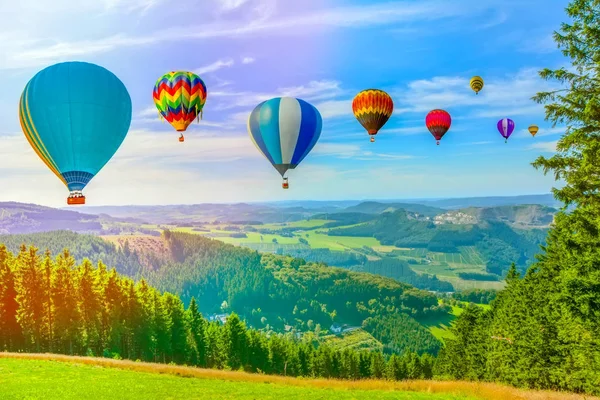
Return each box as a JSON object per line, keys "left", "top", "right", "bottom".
{"left": 19, "top": 62, "right": 131, "bottom": 204}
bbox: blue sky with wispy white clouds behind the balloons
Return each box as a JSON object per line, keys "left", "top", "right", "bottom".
{"left": 0, "top": 0, "right": 568, "bottom": 206}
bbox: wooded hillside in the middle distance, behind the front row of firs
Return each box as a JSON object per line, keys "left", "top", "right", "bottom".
{"left": 0, "top": 231, "right": 450, "bottom": 354}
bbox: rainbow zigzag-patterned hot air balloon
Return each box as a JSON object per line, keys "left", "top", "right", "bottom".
{"left": 153, "top": 71, "right": 206, "bottom": 142}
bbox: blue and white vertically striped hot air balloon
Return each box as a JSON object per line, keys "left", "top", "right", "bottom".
{"left": 248, "top": 97, "right": 323, "bottom": 189}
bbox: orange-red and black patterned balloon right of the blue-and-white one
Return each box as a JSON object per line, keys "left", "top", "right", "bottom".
{"left": 352, "top": 89, "right": 394, "bottom": 142}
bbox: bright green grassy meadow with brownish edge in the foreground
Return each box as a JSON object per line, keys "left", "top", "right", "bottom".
{"left": 0, "top": 353, "right": 598, "bottom": 400}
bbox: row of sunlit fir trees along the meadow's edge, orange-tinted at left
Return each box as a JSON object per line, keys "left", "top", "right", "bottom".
{"left": 0, "top": 245, "right": 434, "bottom": 379}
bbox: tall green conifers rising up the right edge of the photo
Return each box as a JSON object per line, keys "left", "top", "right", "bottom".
{"left": 428, "top": 0, "right": 600, "bottom": 395}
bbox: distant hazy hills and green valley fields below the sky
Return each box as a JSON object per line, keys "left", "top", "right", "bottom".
{"left": 0, "top": 196, "right": 556, "bottom": 291}
